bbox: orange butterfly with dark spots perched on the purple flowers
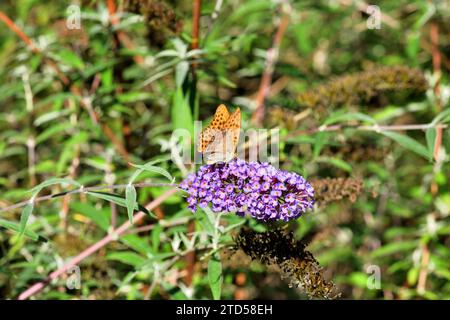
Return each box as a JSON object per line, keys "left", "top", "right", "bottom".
{"left": 197, "top": 104, "right": 241, "bottom": 164}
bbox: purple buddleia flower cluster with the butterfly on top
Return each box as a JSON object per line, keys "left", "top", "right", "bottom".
{"left": 180, "top": 159, "right": 314, "bottom": 221}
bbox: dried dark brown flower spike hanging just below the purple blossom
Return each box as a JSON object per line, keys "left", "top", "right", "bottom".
{"left": 236, "top": 229, "right": 338, "bottom": 299}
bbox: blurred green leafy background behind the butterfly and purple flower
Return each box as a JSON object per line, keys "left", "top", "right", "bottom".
{"left": 0, "top": 0, "right": 450, "bottom": 299}
